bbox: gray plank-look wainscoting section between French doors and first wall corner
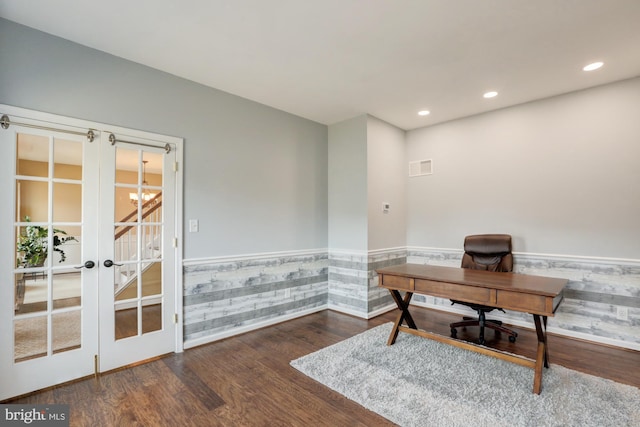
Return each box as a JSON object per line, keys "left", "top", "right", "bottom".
{"left": 183, "top": 250, "right": 329, "bottom": 348}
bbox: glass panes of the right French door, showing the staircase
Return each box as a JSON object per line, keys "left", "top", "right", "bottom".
{"left": 113, "top": 148, "right": 163, "bottom": 340}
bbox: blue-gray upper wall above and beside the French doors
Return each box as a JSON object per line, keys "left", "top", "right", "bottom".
{"left": 0, "top": 19, "right": 327, "bottom": 259}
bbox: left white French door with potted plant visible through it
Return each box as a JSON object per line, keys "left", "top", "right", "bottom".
{"left": 0, "top": 123, "right": 98, "bottom": 399}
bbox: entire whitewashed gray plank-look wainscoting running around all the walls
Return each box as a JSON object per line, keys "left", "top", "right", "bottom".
{"left": 183, "top": 248, "right": 640, "bottom": 350}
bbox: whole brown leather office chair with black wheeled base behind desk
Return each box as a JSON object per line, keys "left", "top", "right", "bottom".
{"left": 449, "top": 234, "right": 518, "bottom": 344}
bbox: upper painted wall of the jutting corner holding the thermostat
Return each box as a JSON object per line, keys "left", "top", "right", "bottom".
{"left": 329, "top": 114, "right": 406, "bottom": 252}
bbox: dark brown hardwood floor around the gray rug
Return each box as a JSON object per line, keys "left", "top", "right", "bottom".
{"left": 5, "top": 308, "right": 640, "bottom": 427}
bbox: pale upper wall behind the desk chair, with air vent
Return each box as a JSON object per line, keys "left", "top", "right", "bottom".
{"left": 407, "top": 78, "right": 640, "bottom": 259}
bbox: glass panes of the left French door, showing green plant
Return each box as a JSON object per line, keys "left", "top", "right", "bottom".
{"left": 14, "top": 133, "right": 83, "bottom": 362}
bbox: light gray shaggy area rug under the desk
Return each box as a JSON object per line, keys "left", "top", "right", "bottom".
{"left": 291, "top": 323, "right": 640, "bottom": 427}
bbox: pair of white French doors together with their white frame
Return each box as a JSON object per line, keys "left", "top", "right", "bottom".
{"left": 0, "top": 106, "right": 181, "bottom": 400}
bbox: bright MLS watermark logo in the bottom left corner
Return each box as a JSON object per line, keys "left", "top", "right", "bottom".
{"left": 0, "top": 405, "right": 69, "bottom": 427}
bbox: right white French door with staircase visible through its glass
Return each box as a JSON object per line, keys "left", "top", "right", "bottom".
{"left": 100, "top": 137, "right": 176, "bottom": 371}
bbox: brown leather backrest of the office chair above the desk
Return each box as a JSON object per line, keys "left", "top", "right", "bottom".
{"left": 461, "top": 234, "right": 513, "bottom": 272}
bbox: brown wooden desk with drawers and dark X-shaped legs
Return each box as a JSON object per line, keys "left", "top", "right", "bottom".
{"left": 376, "top": 264, "right": 567, "bottom": 394}
